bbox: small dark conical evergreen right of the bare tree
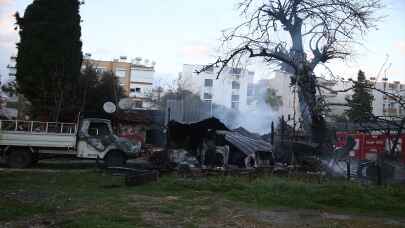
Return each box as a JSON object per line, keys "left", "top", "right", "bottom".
{"left": 346, "top": 70, "right": 374, "bottom": 122}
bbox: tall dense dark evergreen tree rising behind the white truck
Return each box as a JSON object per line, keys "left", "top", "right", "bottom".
{"left": 16, "top": 0, "right": 82, "bottom": 121}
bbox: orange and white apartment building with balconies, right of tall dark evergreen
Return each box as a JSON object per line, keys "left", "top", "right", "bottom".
{"left": 83, "top": 56, "right": 156, "bottom": 109}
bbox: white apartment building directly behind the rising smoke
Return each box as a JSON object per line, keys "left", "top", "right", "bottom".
{"left": 180, "top": 64, "right": 254, "bottom": 112}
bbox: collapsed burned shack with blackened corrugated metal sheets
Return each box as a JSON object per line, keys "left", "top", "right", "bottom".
{"left": 168, "top": 118, "right": 273, "bottom": 168}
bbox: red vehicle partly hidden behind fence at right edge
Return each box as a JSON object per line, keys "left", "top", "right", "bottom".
{"left": 335, "top": 131, "right": 405, "bottom": 164}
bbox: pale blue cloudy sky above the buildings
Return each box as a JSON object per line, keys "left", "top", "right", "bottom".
{"left": 0, "top": 0, "right": 405, "bottom": 86}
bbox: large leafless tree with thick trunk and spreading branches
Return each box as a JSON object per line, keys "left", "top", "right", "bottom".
{"left": 198, "top": 0, "right": 383, "bottom": 141}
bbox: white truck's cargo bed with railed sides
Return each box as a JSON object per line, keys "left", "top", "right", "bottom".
{"left": 0, "top": 120, "right": 77, "bottom": 148}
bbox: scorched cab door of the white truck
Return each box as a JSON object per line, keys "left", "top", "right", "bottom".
{"left": 78, "top": 121, "right": 112, "bottom": 158}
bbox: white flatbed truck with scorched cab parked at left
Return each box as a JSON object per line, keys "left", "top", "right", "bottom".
{"left": 0, "top": 118, "right": 141, "bottom": 168}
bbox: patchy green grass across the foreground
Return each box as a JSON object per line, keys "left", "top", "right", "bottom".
{"left": 0, "top": 169, "right": 405, "bottom": 227}
